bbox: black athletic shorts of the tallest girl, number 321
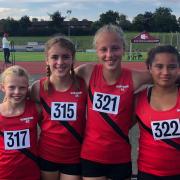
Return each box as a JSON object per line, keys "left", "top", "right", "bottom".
{"left": 81, "top": 159, "right": 132, "bottom": 180}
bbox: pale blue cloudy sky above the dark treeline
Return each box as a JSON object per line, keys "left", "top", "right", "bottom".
{"left": 0, "top": 0, "right": 180, "bottom": 21}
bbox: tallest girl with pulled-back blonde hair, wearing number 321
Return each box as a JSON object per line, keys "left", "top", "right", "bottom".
{"left": 76, "top": 25, "right": 150, "bottom": 180}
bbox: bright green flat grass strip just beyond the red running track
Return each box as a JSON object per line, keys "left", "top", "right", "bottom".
{"left": 0, "top": 52, "right": 146, "bottom": 62}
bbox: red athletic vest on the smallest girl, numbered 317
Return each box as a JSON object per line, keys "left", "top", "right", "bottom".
{"left": 0, "top": 100, "right": 40, "bottom": 180}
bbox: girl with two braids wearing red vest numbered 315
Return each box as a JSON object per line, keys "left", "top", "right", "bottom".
{"left": 31, "top": 36, "right": 86, "bottom": 180}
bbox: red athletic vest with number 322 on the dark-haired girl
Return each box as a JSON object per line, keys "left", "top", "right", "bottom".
{"left": 136, "top": 90, "right": 180, "bottom": 176}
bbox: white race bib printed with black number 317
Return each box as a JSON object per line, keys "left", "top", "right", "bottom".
{"left": 4, "top": 129, "right": 30, "bottom": 150}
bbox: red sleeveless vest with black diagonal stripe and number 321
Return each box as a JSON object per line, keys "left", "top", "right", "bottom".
{"left": 81, "top": 65, "right": 133, "bottom": 164}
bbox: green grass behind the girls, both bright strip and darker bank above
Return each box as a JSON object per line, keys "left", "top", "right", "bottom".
{"left": 0, "top": 32, "right": 177, "bottom": 61}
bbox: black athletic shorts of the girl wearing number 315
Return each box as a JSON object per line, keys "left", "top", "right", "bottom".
{"left": 39, "top": 158, "right": 81, "bottom": 176}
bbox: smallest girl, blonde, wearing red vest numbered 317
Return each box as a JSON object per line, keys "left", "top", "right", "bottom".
{"left": 0, "top": 66, "right": 40, "bottom": 180}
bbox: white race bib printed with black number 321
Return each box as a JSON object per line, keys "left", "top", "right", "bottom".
{"left": 93, "top": 92, "right": 120, "bottom": 114}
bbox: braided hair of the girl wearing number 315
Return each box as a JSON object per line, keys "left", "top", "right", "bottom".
{"left": 44, "top": 35, "right": 79, "bottom": 92}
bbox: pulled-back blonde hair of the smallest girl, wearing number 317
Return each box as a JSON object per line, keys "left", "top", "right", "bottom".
{"left": 0, "top": 65, "right": 29, "bottom": 84}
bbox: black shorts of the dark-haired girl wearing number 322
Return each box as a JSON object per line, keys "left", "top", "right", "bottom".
{"left": 137, "top": 171, "right": 180, "bottom": 180}
